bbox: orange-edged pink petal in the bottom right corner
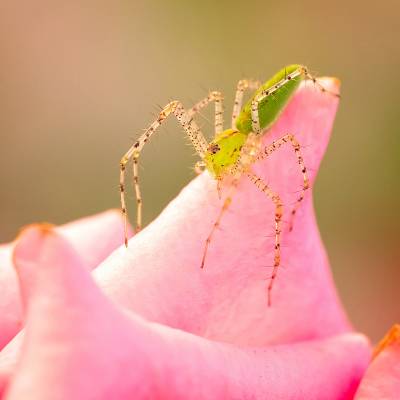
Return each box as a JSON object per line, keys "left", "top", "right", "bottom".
{"left": 356, "top": 325, "right": 400, "bottom": 400}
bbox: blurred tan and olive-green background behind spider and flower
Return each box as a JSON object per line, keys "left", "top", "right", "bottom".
{"left": 0, "top": 0, "right": 400, "bottom": 341}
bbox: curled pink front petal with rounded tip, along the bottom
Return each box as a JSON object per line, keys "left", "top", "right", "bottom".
{"left": 6, "top": 228, "right": 369, "bottom": 400}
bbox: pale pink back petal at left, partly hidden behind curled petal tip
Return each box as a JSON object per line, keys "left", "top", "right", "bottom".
{"left": 0, "top": 210, "right": 130, "bottom": 349}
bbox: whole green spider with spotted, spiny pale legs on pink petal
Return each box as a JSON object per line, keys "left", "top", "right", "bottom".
{"left": 120, "top": 64, "right": 338, "bottom": 305}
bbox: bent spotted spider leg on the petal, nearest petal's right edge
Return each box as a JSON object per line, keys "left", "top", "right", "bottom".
{"left": 256, "top": 133, "right": 310, "bottom": 231}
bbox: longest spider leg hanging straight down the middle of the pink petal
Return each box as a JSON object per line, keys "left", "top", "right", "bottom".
{"left": 246, "top": 171, "right": 283, "bottom": 306}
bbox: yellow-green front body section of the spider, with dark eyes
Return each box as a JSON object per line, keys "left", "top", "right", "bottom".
{"left": 204, "top": 129, "right": 247, "bottom": 179}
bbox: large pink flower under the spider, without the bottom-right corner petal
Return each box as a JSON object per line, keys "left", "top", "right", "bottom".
{"left": 0, "top": 79, "right": 380, "bottom": 400}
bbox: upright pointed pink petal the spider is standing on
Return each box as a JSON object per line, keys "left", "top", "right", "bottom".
{"left": 94, "top": 78, "right": 350, "bottom": 346}
